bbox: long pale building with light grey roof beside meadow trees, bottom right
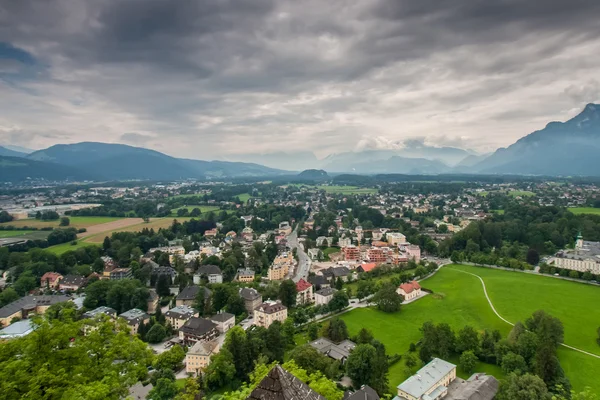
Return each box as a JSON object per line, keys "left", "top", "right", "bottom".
{"left": 394, "top": 358, "right": 456, "bottom": 400}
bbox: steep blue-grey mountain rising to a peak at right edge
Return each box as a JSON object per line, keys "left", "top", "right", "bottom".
{"left": 474, "top": 104, "right": 600, "bottom": 176}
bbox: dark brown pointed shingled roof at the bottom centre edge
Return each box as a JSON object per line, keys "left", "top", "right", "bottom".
{"left": 246, "top": 365, "right": 325, "bottom": 400}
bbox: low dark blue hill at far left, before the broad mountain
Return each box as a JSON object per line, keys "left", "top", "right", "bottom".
{"left": 0, "top": 156, "right": 98, "bottom": 182}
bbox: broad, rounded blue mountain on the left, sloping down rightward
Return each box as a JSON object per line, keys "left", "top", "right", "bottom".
{"left": 1, "top": 142, "right": 284, "bottom": 180}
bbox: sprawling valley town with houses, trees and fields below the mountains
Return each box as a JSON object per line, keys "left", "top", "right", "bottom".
{"left": 0, "top": 179, "right": 600, "bottom": 400}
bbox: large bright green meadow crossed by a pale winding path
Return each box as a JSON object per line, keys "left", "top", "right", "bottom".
{"left": 342, "top": 265, "right": 600, "bottom": 391}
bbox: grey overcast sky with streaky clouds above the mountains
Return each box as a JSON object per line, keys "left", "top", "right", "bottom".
{"left": 0, "top": 0, "right": 600, "bottom": 159}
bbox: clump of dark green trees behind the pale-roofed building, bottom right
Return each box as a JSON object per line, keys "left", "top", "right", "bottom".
{"left": 406, "top": 310, "right": 571, "bottom": 400}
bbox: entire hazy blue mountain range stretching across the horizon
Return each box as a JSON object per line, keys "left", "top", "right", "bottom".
{"left": 0, "top": 104, "right": 600, "bottom": 181}
